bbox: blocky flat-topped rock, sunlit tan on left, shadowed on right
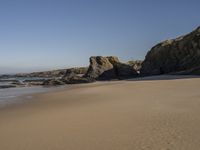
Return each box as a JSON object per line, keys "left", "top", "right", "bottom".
{"left": 85, "top": 56, "right": 137, "bottom": 80}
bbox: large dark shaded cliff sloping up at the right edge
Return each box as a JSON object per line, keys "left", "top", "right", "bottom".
{"left": 141, "top": 27, "right": 200, "bottom": 75}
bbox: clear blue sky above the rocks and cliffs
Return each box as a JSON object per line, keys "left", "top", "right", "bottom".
{"left": 0, "top": 0, "right": 200, "bottom": 74}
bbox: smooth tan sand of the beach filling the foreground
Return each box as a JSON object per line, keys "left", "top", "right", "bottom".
{"left": 0, "top": 75, "right": 200, "bottom": 150}
